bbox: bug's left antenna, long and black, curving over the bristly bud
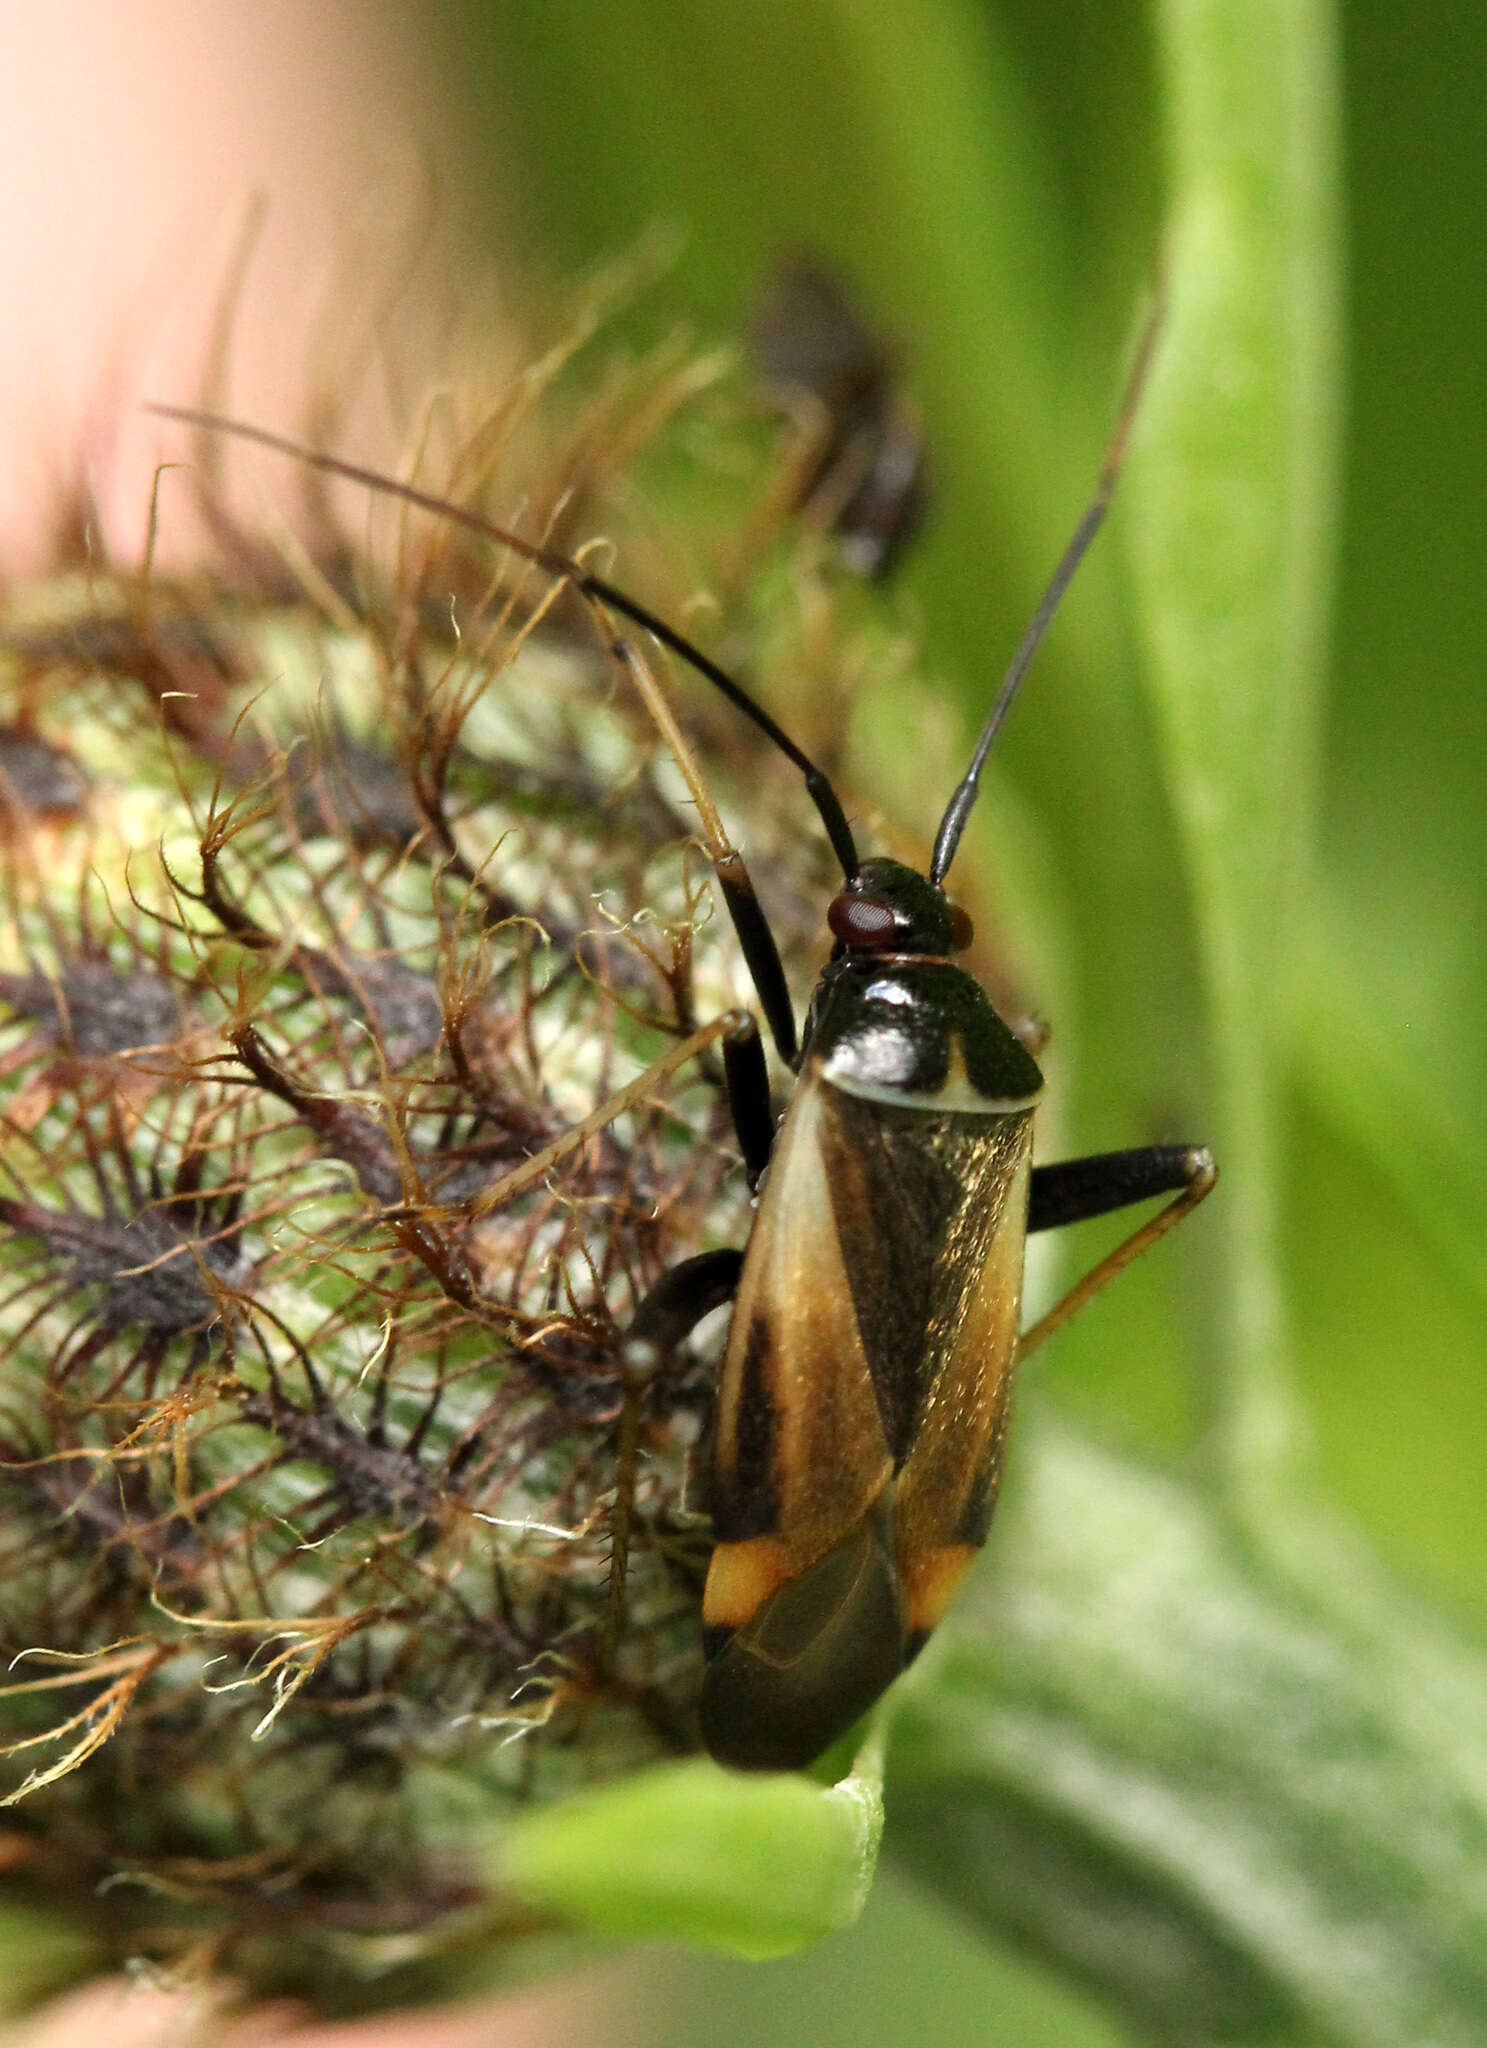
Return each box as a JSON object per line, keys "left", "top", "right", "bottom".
{"left": 145, "top": 406, "right": 860, "bottom": 881}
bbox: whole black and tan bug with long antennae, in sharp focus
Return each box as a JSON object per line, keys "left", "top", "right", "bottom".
{"left": 156, "top": 311, "right": 1217, "bottom": 1769}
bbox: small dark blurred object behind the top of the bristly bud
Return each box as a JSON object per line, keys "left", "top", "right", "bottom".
{"left": 750, "top": 256, "right": 928, "bottom": 582}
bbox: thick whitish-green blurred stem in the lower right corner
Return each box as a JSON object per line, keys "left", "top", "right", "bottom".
{"left": 889, "top": 1417, "right": 1487, "bottom": 2048}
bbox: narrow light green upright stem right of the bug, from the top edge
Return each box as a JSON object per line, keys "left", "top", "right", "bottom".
{"left": 1127, "top": 0, "right": 1340, "bottom": 1534}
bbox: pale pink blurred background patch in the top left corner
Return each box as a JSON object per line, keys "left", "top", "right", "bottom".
{"left": 0, "top": 0, "right": 492, "bottom": 571}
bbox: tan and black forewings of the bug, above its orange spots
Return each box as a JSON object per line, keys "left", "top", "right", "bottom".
{"left": 715, "top": 1069, "right": 1032, "bottom": 1575}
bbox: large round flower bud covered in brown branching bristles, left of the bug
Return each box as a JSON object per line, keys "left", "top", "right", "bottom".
{"left": 0, "top": 299, "right": 897, "bottom": 2003}
